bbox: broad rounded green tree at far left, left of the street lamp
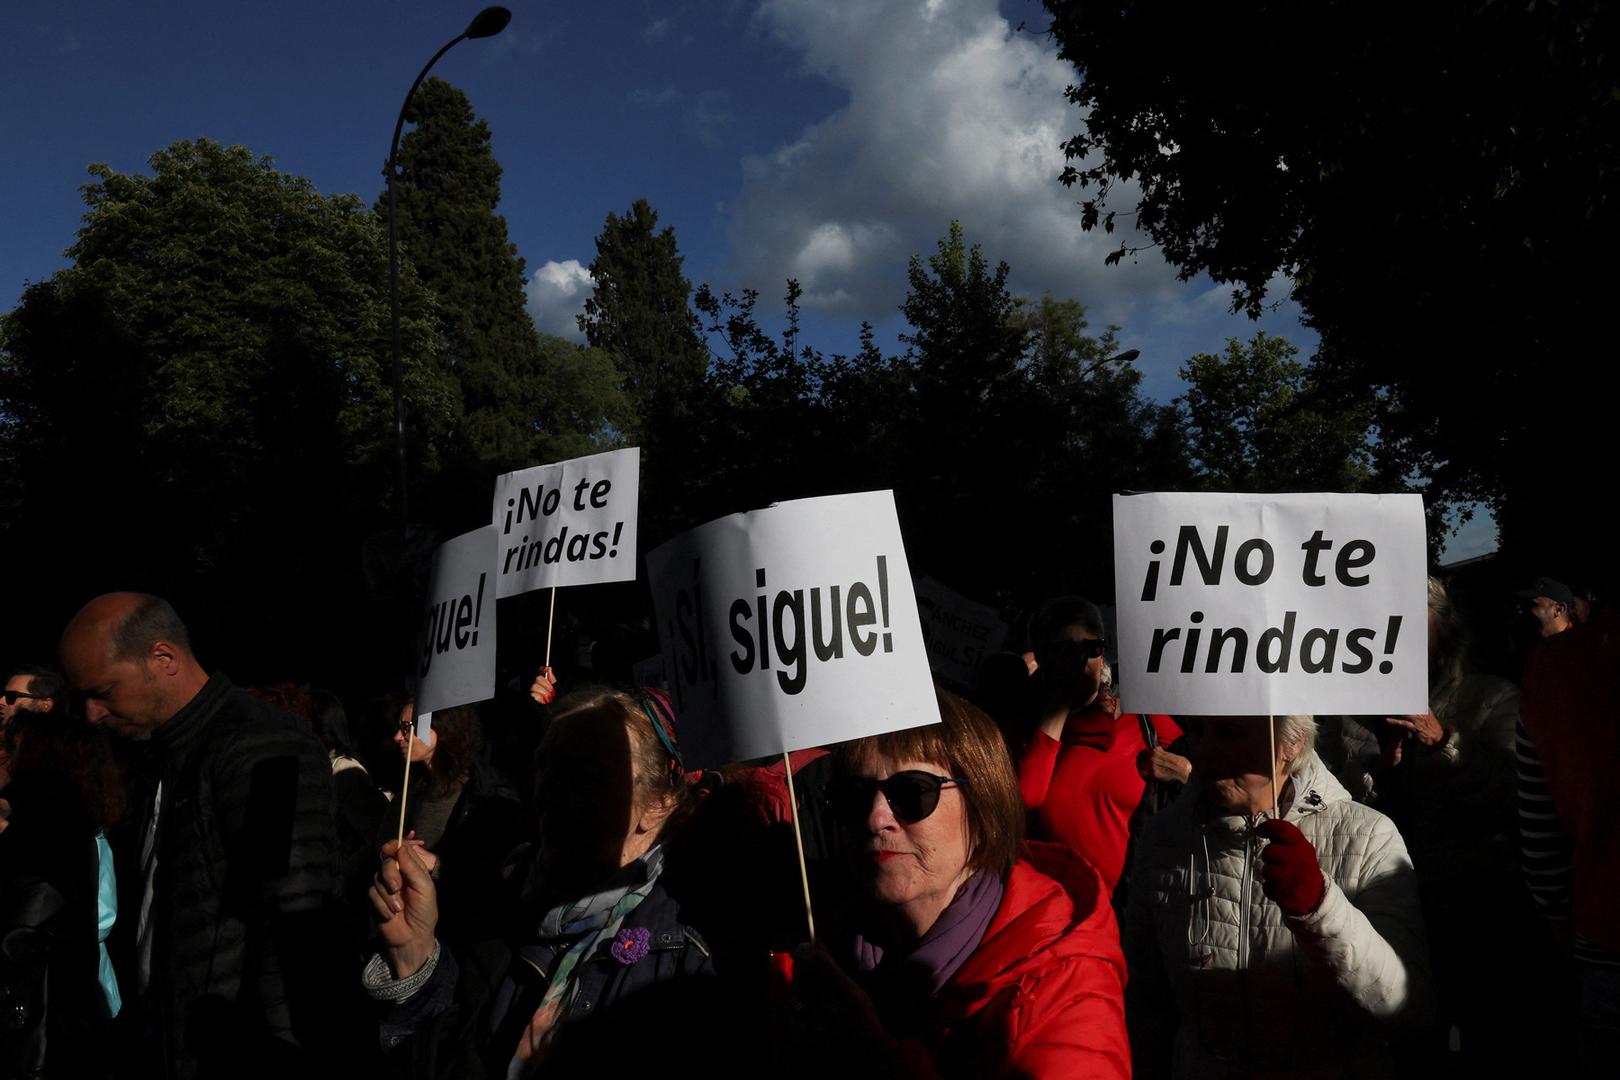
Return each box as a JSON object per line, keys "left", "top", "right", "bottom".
{"left": 0, "top": 139, "right": 455, "bottom": 674}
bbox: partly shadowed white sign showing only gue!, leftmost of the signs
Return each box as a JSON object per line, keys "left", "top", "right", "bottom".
{"left": 416, "top": 525, "right": 496, "bottom": 718}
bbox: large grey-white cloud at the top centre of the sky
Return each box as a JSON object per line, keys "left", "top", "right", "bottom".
{"left": 732, "top": 0, "right": 1196, "bottom": 324}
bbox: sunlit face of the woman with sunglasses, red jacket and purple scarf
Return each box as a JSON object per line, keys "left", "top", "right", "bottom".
{"left": 849, "top": 756, "right": 972, "bottom": 923}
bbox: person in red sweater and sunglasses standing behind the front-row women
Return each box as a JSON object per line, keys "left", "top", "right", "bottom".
{"left": 1019, "top": 596, "right": 1192, "bottom": 894}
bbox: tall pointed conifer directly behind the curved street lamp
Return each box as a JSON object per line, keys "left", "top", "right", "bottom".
{"left": 377, "top": 79, "right": 632, "bottom": 521}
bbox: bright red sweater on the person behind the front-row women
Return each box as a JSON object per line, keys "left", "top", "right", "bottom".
{"left": 1017, "top": 704, "right": 1181, "bottom": 894}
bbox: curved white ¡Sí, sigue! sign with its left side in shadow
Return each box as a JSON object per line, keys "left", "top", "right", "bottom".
{"left": 646, "top": 491, "right": 940, "bottom": 767}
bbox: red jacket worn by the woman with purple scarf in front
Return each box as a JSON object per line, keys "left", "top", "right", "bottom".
{"left": 919, "top": 844, "right": 1131, "bottom": 1080}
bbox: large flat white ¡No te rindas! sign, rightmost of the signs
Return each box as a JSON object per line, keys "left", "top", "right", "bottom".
{"left": 1113, "top": 492, "right": 1429, "bottom": 716}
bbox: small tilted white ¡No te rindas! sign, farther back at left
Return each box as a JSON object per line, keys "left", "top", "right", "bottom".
{"left": 491, "top": 447, "right": 642, "bottom": 599}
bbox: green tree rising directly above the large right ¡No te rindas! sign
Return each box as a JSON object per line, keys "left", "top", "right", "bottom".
{"left": 1176, "top": 330, "right": 1374, "bottom": 491}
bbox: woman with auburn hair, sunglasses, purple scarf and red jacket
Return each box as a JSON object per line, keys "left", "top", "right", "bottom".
{"left": 786, "top": 691, "right": 1131, "bottom": 1078}
